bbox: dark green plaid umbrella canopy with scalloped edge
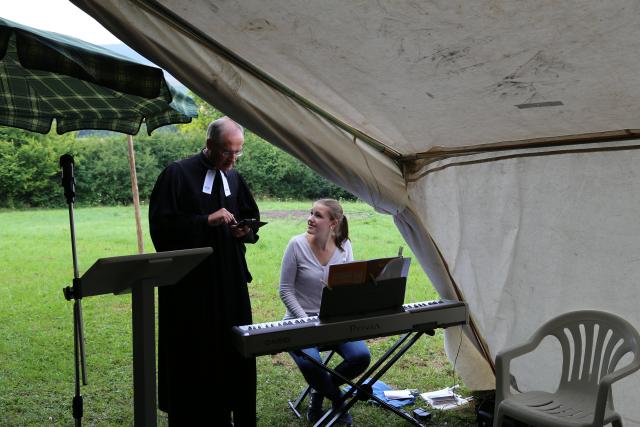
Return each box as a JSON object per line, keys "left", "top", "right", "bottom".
{"left": 0, "top": 18, "right": 197, "bottom": 135}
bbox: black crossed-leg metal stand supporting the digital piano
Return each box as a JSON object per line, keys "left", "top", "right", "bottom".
{"left": 296, "top": 327, "right": 434, "bottom": 427}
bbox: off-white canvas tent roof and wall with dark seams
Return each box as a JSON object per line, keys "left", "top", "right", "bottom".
{"left": 72, "top": 0, "right": 640, "bottom": 425}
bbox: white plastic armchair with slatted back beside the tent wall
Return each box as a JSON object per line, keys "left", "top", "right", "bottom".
{"left": 493, "top": 310, "right": 640, "bottom": 427}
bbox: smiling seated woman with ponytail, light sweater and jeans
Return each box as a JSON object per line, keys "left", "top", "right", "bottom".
{"left": 280, "top": 199, "right": 371, "bottom": 424}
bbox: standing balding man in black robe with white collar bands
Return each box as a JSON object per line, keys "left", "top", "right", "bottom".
{"left": 149, "top": 117, "right": 260, "bottom": 427}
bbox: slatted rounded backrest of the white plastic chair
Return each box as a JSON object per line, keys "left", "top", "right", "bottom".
{"left": 538, "top": 310, "right": 640, "bottom": 390}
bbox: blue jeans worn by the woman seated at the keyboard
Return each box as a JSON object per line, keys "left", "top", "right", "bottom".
{"left": 289, "top": 341, "right": 371, "bottom": 400}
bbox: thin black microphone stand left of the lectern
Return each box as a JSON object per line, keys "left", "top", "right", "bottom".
{"left": 60, "top": 154, "right": 87, "bottom": 427}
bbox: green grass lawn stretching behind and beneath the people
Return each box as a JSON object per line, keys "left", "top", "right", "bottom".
{"left": 0, "top": 201, "right": 474, "bottom": 426}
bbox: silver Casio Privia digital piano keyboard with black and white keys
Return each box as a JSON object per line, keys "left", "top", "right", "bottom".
{"left": 233, "top": 300, "right": 467, "bottom": 357}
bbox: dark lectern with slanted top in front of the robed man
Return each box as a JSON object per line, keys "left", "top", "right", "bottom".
{"left": 78, "top": 248, "right": 213, "bottom": 427}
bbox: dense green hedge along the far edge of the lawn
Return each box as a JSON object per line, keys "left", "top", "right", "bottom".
{"left": 0, "top": 128, "right": 355, "bottom": 208}
